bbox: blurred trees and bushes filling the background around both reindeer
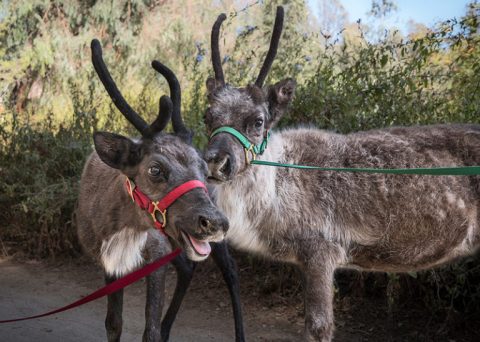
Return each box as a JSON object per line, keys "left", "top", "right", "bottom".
{"left": 0, "top": 0, "right": 480, "bottom": 326}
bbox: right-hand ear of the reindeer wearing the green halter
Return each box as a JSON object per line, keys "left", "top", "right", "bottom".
{"left": 267, "top": 78, "right": 297, "bottom": 128}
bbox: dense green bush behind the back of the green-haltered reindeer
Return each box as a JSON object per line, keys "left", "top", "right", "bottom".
{"left": 283, "top": 7, "right": 480, "bottom": 133}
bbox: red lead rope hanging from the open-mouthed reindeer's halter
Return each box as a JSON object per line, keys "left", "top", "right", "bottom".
{"left": 0, "top": 248, "right": 182, "bottom": 324}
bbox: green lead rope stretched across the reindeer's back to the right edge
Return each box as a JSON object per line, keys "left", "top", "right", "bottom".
{"left": 251, "top": 160, "right": 480, "bottom": 176}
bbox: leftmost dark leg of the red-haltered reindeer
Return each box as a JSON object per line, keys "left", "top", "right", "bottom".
{"left": 105, "top": 274, "right": 123, "bottom": 342}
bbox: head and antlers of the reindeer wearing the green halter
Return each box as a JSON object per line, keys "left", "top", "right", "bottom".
{"left": 205, "top": 7, "right": 296, "bottom": 181}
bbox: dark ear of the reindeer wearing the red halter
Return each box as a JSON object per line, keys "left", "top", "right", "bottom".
{"left": 93, "top": 132, "right": 143, "bottom": 171}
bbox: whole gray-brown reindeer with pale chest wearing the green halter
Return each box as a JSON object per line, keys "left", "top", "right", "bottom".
{"left": 205, "top": 8, "right": 480, "bottom": 341}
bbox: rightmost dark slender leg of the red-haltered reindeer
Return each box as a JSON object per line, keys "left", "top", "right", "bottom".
{"left": 212, "top": 241, "right": 245, "bottom": 342}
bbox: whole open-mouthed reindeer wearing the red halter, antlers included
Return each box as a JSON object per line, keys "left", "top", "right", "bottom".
{"left": 76, "top": 40, "right": 243, "bottom": 341}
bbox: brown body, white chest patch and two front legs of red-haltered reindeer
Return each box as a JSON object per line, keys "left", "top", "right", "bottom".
{"left": 76, "top": 152, "right": 171, "bottom": 341}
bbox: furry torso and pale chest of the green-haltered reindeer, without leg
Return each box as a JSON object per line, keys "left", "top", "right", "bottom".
{"left": 217, "top": 125, "right": 480, "bottom": 272}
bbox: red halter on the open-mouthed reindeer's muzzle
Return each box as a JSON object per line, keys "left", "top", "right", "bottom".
{"left": 125, "top": 177, "right": 208, "bottom": 232}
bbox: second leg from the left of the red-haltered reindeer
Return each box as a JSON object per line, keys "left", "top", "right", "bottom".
{"left": 143, "top": 231, "right": 171, "bottom": 342}
